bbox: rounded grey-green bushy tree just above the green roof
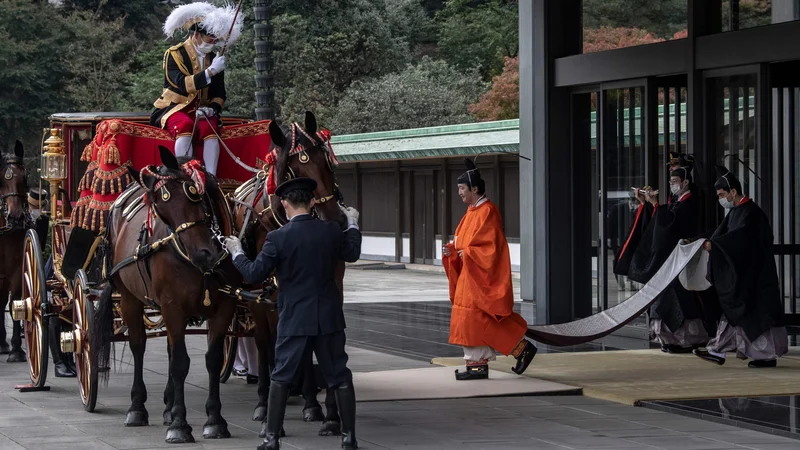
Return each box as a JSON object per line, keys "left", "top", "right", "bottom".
{"left": 323, "top": 57, "right": 486, "bottom": 134}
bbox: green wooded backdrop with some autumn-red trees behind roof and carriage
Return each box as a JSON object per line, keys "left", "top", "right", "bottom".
{"left": 0, "top": 0, "right": 769, "bottom": 171}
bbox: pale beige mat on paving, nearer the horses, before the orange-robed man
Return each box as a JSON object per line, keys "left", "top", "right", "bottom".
{"left": 346, "top": 368, "right": 580, "bottom": 402}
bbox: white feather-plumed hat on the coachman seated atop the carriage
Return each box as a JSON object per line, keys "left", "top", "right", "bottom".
{"left": 164, "top": 2, "right": 244, "bottom": 46}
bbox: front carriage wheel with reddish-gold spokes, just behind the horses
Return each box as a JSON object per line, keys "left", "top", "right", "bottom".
{"left": 72, "top": 269, "right": 97, "bottom": 412}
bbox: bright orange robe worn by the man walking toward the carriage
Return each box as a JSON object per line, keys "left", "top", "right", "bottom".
{"left": 442, "top": 200, "right": 528, "bottom": 355}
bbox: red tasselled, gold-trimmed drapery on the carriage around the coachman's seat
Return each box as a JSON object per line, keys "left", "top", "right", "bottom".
{"left": 71, "top": 119, "right": 272, "bottom": 232}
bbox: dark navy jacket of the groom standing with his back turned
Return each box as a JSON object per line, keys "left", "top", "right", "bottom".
{"left": 233, "top": 214, "right": 361, "bottom": 338}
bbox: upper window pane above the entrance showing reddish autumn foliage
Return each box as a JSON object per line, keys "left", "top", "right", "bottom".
{"left": 583, "top": 0, "right": 687, "bottom": 53}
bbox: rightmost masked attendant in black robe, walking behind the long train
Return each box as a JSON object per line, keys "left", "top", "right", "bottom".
{"left": 695, "top": 166, "right": 788, "bottom": 368}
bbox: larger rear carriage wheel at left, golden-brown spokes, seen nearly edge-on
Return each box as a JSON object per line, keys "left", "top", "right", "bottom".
{"left": 22, "top": 230, "right": 50, "bottom": 388}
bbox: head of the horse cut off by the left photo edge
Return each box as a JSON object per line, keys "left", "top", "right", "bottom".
{"left": 0, "top": 141, "right": 31, "bottom": 231}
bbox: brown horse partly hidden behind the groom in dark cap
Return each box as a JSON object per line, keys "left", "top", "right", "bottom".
{"left": 228, "top": 112, "right": 346, "bottom": 437}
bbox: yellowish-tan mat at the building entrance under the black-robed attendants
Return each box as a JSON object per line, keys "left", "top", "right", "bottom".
{"left": 432, "top": 348, "right": 800, "bottom": 405}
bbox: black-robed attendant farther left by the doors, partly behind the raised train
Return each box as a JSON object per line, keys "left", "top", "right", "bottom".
{"left": 617, "top": 166, "right": 708, "bottom": 353}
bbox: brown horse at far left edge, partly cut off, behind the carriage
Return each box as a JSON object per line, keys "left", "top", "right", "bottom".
{"left": 0, "top": 141, "right": 33, "bottom": 362}
